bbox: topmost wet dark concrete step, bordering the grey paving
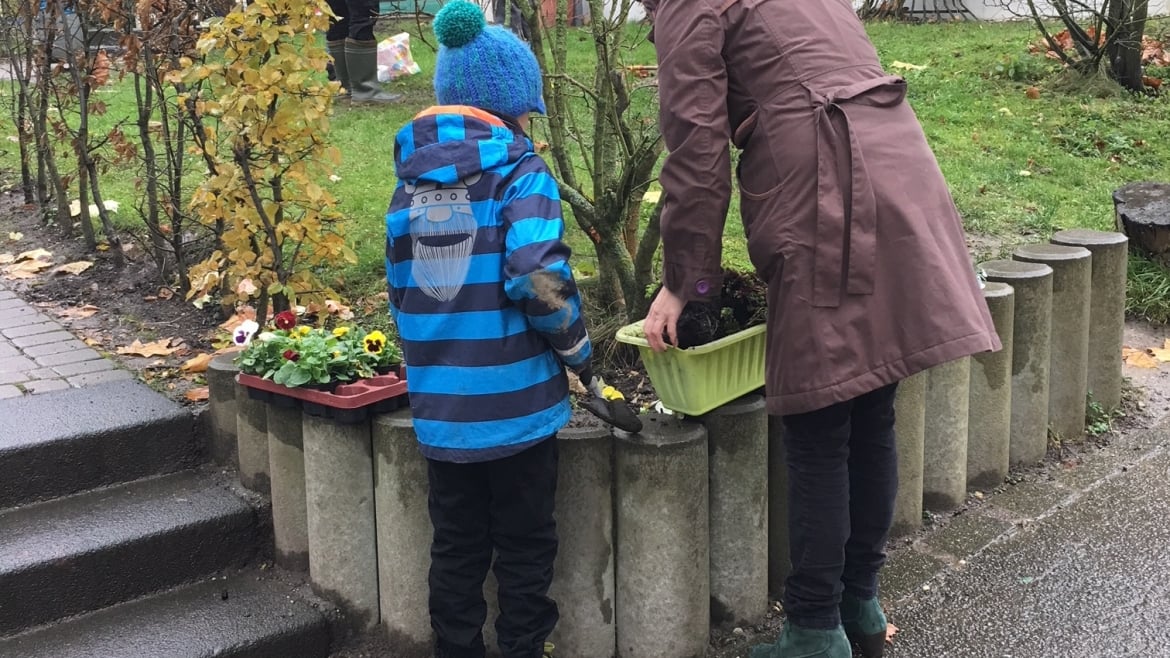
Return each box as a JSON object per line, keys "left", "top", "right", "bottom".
{"left": 0, "top": 381, "right": 198, "bottom": 508}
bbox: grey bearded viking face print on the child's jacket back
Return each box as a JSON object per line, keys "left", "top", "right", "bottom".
{"left": 405, "top": 173, "right": 480, "bottom": 302}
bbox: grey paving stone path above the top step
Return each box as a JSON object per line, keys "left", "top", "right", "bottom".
{"left": 0, "top": 276, "right": 133, "bottom": 399}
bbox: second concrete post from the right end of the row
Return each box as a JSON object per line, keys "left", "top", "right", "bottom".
{"left": 1014, "top": 245, "right": 1095, "bottom": 440}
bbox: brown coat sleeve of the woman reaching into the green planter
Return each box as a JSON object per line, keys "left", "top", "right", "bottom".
{"left": 654, "top": 0, "right": 731, "bottom": 301}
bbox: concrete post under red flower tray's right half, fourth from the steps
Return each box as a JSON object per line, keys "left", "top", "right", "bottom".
{"left": 303, "top": 414, "right": 379, "bottom": 630}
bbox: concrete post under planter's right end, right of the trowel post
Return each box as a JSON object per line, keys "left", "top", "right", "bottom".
{"left": 700, "top": 393, "right": 769, "bottom": 630}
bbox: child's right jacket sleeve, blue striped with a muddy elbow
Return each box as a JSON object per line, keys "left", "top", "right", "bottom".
{"left": 501, "top": 158, "right": 593, "bottom": 371}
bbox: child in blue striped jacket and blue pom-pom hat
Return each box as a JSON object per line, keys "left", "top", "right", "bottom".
{"left": 386, "top": 0, "right": 592, "bottom": 658}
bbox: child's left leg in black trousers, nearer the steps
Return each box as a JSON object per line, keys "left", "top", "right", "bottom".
{"left": 427, "top": 460, "right": 491, "bottom": 658}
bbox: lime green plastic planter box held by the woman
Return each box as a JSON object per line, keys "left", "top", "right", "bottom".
{"left": 618, "top": 321, "right": 765, "bottom": 416}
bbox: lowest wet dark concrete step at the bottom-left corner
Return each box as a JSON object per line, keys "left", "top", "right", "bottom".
{"left": 0, "top": 571, "right": 330, "bottom": 658}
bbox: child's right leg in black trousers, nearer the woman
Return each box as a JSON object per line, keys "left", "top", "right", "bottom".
{"left": 489, "top": 436, "right": 559, "bottom": 658}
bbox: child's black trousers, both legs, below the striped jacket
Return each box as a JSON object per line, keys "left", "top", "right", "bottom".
{"left": 427, "top": 436, "right": 558, "bottom": 658}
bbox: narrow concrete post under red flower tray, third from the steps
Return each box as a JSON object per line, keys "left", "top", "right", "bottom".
{"left": 267, "top": 404, "right": 309, "bottom": 571}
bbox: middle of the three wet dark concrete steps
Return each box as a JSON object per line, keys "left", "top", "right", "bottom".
{"left": 0, "top": 472, "right": 261, "bottom": 635}
